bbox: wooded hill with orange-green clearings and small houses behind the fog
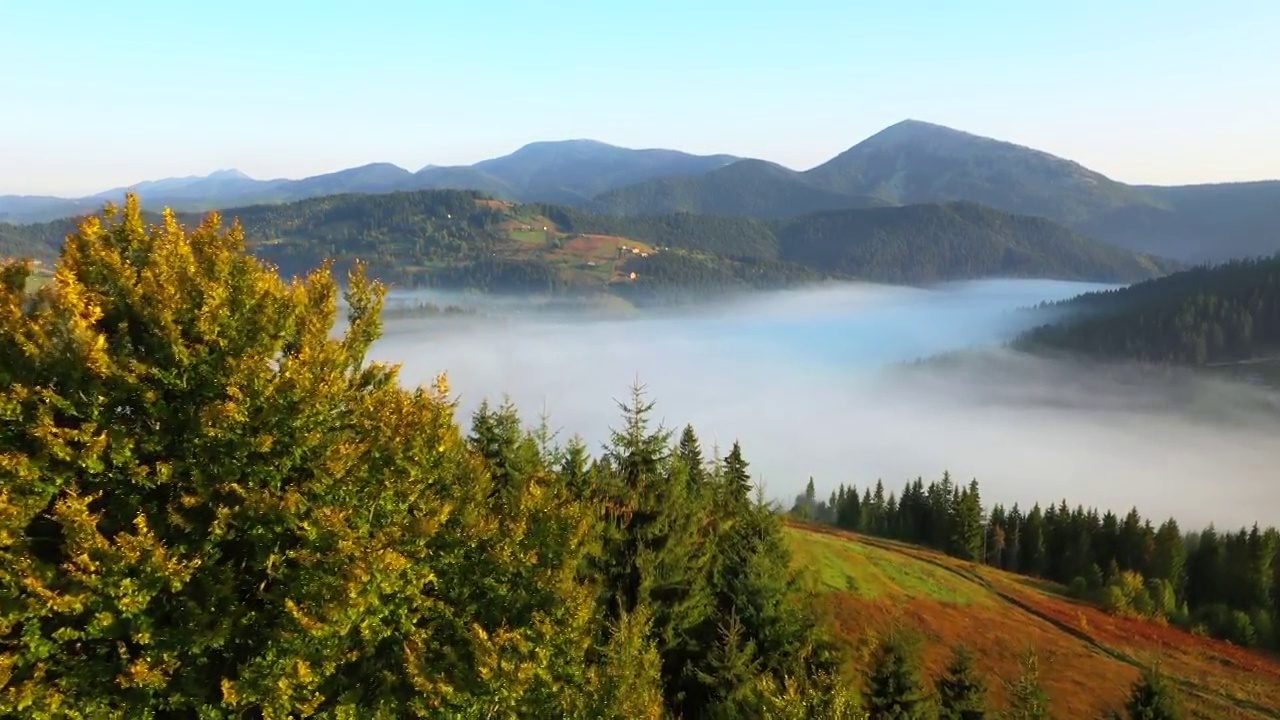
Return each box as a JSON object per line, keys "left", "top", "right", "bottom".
{"left": 202, "top": 190, "right": 820, "bottom": 302}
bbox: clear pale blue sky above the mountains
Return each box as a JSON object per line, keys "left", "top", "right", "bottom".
{"left": 0, "top": 0, "right": 1280, "bottom": 195}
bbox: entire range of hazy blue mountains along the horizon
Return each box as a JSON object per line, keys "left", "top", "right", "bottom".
{"left": 0, "top": 120, "right": 1280, "bottom": 263}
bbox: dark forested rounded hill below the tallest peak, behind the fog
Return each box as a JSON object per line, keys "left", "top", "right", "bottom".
{"left": 778, "top": 202, "right": 1175, "bottom": 283}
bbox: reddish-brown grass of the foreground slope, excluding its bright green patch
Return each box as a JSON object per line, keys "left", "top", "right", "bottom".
{"left": 792, "top": 524, "right": 1280, "bottom": 719}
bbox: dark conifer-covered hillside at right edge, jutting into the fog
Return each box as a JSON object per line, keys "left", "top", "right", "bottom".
{"left": 1019, "top": 255, "right": 1280, "bottom": 365}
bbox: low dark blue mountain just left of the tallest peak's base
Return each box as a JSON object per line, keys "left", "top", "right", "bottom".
{"left": 586, "top": 160, "right": 887, "bottom": 218}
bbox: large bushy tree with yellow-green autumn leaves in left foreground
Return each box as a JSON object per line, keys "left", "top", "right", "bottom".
{"left": 0, "top": 196, "right": 660, "bottom": 719}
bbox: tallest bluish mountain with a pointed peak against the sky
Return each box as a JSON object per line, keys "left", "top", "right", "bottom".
{"left": 804, "top": 120, "right": 1155, "bottom": 223}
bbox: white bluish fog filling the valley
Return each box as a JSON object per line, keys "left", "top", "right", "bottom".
{"left": 371, "top": 281, "right": 1280, "bottom": 527}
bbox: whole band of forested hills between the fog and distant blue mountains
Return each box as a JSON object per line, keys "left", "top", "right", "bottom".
{"left": 0, "top": 191, "right": 1170, "bottom": 293}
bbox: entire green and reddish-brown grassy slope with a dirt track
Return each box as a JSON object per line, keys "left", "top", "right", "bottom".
{"left": 788, "top": 524, "right": 1280, "bottom": 719}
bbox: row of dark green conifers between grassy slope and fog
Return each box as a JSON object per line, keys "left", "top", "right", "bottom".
{"left": 791, "top": 473, "right": 1280, "bottom": 650}
